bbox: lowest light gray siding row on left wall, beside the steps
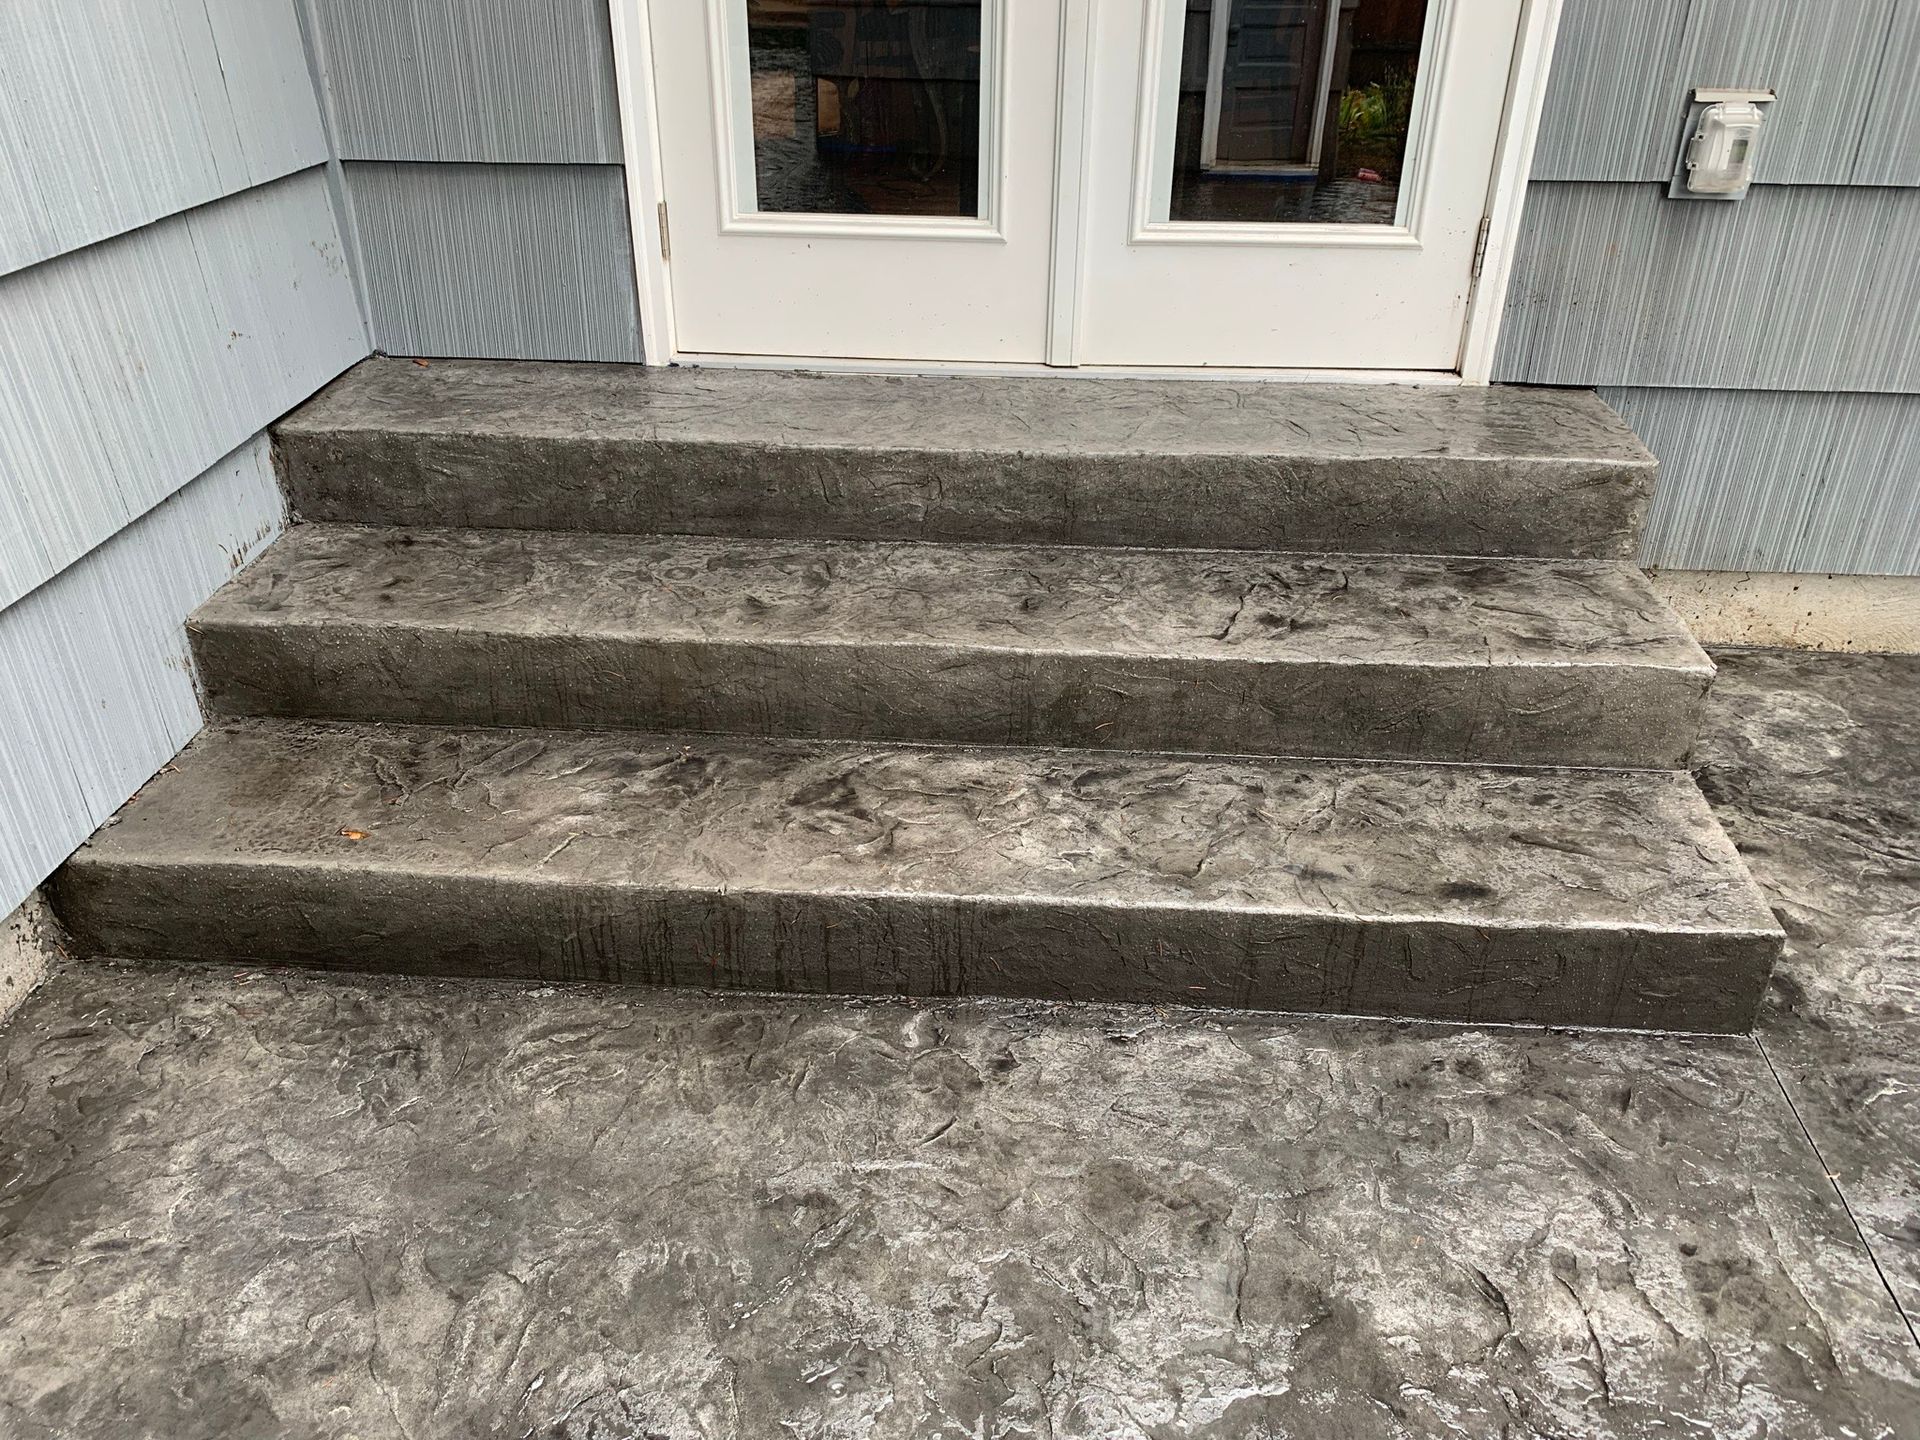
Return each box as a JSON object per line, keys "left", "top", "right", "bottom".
{"left": 0, "top": 436, "right": 280, "bottom": 914}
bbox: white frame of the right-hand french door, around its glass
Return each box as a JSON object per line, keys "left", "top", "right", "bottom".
{"left": 1077, "top": 0, "right": 1521, "bottom": 371}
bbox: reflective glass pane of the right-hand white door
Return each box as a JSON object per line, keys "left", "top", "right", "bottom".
{"left": 1169, "top": 0, "right": 1428, "bottom": 225}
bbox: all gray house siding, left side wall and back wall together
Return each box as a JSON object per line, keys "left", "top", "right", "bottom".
{"left": 0, "top": 0, "right": 1920, "bottom": 914}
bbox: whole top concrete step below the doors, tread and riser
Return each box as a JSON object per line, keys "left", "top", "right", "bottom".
{"left": 276, "top": 359, "right": 1655, "bottom": 559}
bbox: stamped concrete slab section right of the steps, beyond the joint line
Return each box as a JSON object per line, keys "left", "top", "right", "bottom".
{"left": 1695, "top": 651, "right": 1920, "bottom": 1321}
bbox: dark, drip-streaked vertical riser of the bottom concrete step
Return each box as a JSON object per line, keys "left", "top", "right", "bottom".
{"left": 58, "top": 862, "right": 1774, "bottom": 1033}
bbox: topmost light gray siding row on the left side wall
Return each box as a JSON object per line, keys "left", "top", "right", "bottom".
{"left": 0, "top": 0, "right": 326, "bottom": 275}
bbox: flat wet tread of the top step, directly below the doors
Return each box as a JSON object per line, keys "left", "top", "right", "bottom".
{"left": 278, "top": 357, "right": 1655, "bottom": 470}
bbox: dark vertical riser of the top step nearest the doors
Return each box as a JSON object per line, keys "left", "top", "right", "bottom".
{"left": 278, "top": 430, "right": 1653, "bottom": 559}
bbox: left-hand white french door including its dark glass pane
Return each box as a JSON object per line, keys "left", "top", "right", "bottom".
{"left": 651, "top": 0, "right": 1060, "bottom": 363}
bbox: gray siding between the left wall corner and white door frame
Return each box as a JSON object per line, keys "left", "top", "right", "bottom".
{"left": 303, "top": 0, "right": 641, "bottom": 361}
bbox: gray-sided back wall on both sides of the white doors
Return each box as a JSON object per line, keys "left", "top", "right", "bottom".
{"left": 303, "top": 0, "right": 1920, "bottom": 587}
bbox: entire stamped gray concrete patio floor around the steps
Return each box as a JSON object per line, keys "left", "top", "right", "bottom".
{"left": 0, "top": 655, "right": 1920, "bottom": 1440}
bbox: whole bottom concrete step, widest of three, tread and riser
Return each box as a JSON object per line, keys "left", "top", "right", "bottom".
{"left": 56, "top": 720, "right": 1782, "bottom": 1031}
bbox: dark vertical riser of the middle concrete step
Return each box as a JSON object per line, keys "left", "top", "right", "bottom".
{"left": 192, "top": 622, "right": 1707, "bottom": 768}
